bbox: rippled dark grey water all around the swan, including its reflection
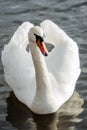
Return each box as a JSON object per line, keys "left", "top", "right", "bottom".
{"left": 0, "top": 0, "right": 87, "bottom": 130}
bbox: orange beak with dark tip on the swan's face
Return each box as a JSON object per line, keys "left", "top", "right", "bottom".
{"left": 37, "top": 39, "right": 48, "bottom": 56}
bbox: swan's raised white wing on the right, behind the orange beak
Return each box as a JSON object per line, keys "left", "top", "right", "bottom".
{"left": 40, "top": 20, "right": 80, "bottom": 98}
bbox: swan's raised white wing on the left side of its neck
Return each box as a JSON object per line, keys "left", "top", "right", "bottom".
{"left": 1, "top": 22, "right": 35, "bottom": 107}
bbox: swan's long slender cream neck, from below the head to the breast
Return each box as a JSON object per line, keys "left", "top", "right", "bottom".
{"left": 30, "top": 42, "right": 51, "bottom": 91}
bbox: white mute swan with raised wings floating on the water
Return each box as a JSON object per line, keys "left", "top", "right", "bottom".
{"left": 1, "top": 20, "right": 80, "bottom": 114}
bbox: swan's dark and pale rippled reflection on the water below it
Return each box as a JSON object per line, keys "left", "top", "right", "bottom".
{"left": 6, "top": 92, "right": 84, "bottom": 130}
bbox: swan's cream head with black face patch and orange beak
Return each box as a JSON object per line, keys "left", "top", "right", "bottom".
{"left": 29, "top": 26, "right": 48, "bottom": 56}
